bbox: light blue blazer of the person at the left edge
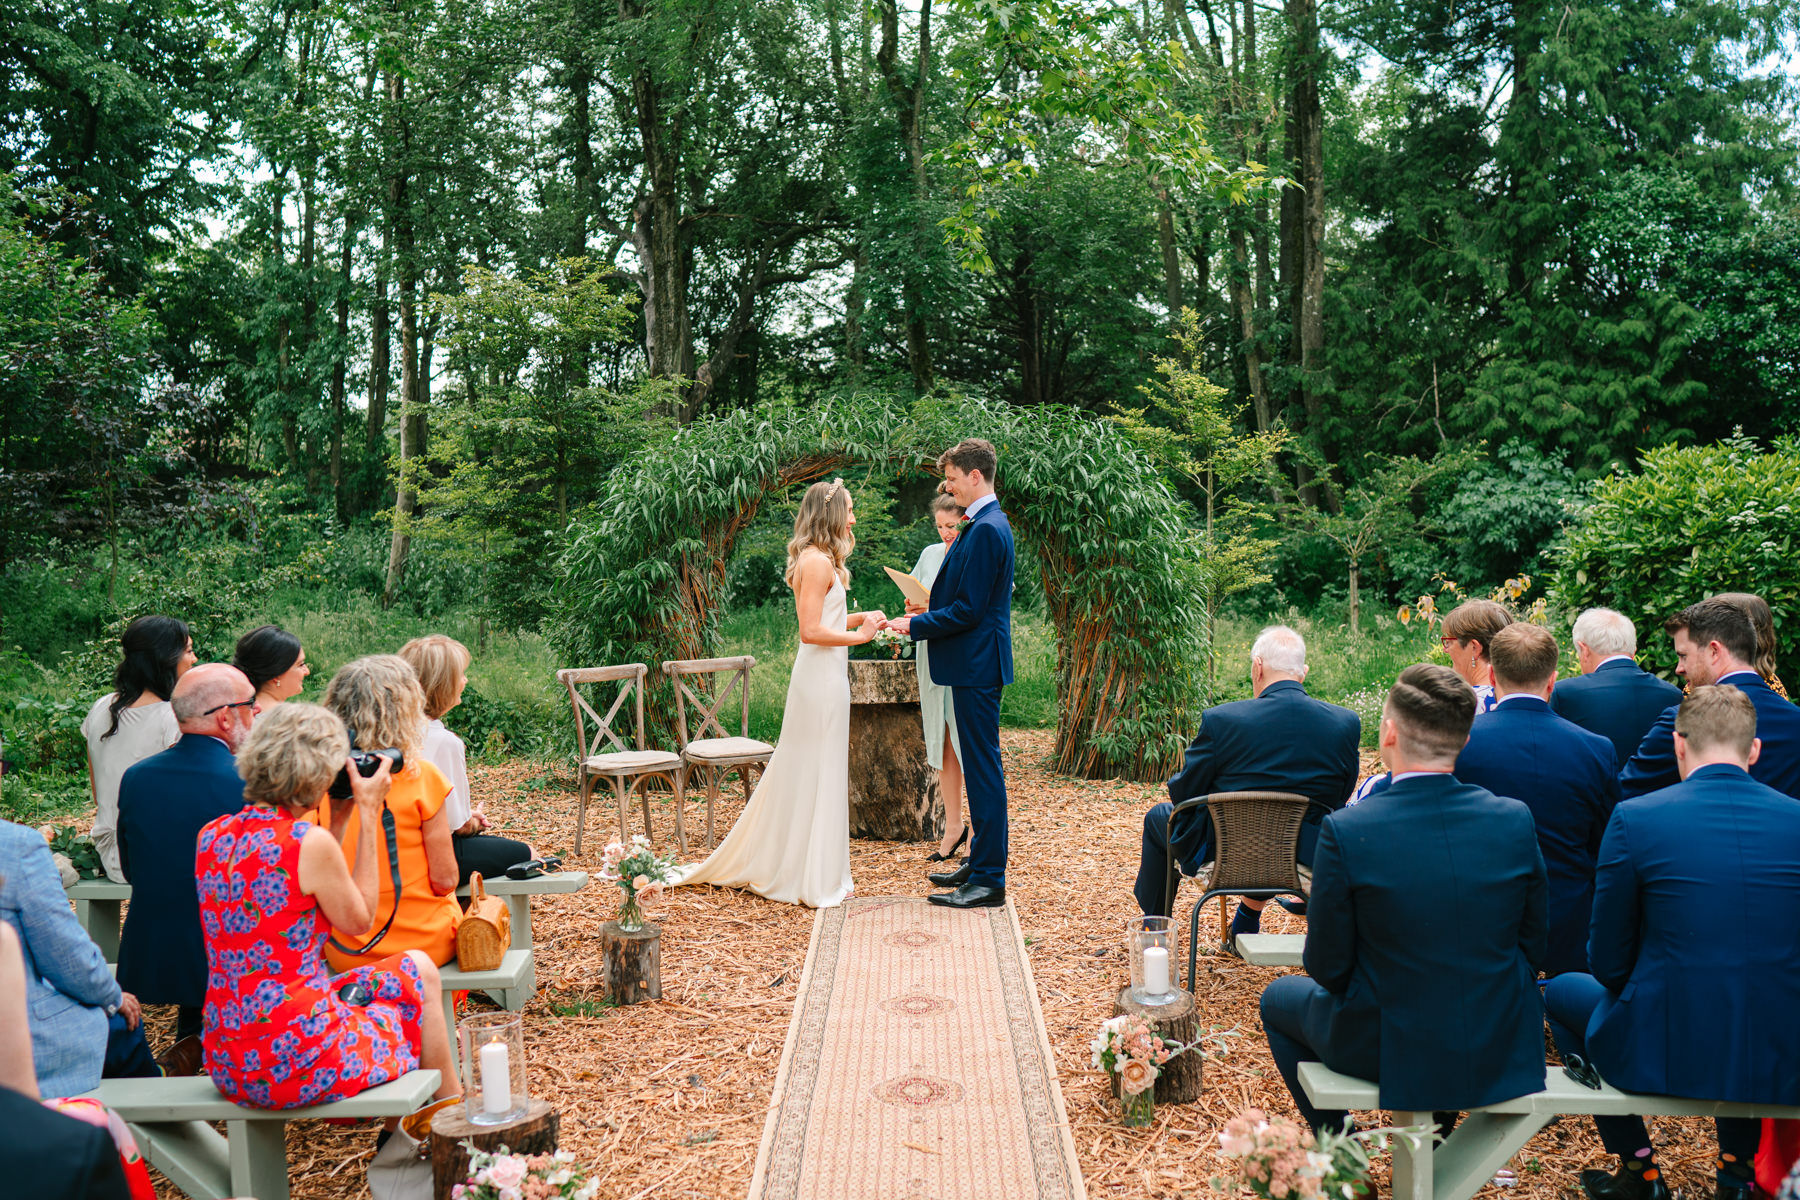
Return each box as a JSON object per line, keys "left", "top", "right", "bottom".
{"left": 0, "top": 820, "right": 122, "bottom": 1099}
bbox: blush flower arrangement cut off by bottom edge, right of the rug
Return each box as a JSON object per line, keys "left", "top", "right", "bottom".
{"left": 1213, "top": 1108, "right": 1433, "bottom": 1200}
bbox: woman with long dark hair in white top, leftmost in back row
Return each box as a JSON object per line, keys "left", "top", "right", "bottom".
{"left": 81, "top": 617, "right": 194, "bottom": 883}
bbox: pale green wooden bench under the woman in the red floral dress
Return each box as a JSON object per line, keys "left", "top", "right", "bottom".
{"left": 88, "top": 1070, "right": 439, "bottom": 1200}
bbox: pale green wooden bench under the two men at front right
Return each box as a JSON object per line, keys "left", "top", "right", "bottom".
{"left": 1300, "top": 1063, "right": 1800, "bottom": 1200}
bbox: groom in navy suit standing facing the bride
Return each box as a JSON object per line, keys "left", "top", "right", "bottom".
{"left": 887, "top": 437, "right": 1013, "bottom": 909}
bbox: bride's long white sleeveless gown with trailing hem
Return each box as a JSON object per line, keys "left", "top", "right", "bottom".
{"left": 680, "top": 583, "right": 851, "bottom": 909}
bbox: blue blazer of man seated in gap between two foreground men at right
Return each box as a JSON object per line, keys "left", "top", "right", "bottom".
{"left": 1456, "top": 693, "right": 1618, "bottom": 975}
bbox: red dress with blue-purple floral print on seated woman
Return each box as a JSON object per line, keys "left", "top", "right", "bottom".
{"left": 194, "top": 806, "right": 423, "bottom": 1108}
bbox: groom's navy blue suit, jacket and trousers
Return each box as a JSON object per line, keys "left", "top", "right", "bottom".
{"left": 911, "top": 500, "right": 1013, "bottom": 887}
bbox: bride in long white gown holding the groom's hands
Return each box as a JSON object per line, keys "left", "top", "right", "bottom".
{"left": 679, "top": 479, "right": 886, "bottom": 909}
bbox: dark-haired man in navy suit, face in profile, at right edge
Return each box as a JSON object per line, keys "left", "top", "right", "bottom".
{"left": 1618, "top": 597, "right": 1800, "bottom": 801}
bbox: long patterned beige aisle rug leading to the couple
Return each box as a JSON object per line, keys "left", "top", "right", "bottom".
{"left": 751, "top": 898, "right": 1085, "bottom": 1200}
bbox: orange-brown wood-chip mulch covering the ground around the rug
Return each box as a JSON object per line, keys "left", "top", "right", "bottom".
{"left": 153, "top": 730, "right": 1714, "bottom": 1200}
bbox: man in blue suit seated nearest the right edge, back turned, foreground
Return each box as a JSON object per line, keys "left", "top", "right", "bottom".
{"left": 1544, "top": 683, "right": 1800, "bottom": 1200}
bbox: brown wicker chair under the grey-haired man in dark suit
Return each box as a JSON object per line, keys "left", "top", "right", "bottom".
{"left": 1165, "top": 792, "right": 1312, "bottom": 991}
